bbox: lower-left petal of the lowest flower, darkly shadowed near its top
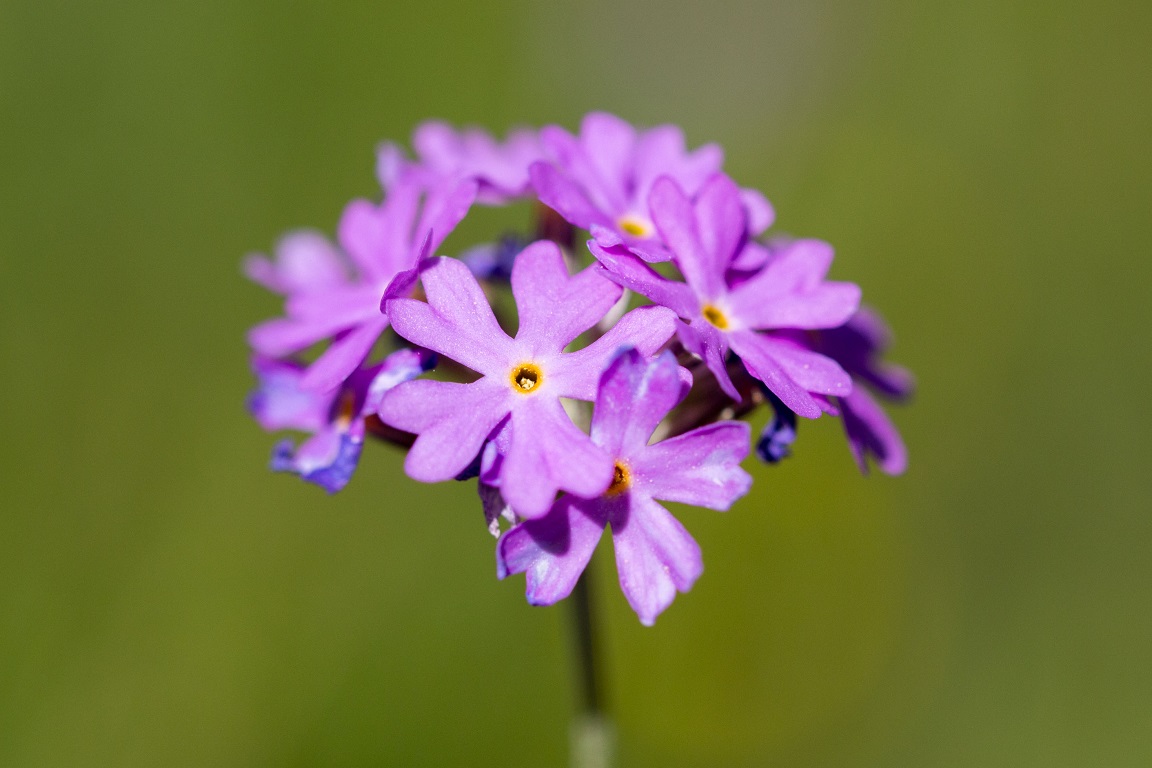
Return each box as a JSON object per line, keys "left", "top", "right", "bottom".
{"left": 497, "top": 496, "right": 604, "bottom": 606}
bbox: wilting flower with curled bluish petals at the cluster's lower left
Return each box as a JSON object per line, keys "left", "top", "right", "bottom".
{"left": 248, "top": 349, "right": 435, "bottom": 493}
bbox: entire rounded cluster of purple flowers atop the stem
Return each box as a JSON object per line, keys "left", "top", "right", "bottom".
{"left": 245, "top": 113, "right": 911, "bottom": 624}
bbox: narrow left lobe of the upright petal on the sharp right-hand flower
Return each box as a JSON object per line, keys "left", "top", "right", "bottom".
{"left": 649, "top": 177, "right": 727, "bottom": 302}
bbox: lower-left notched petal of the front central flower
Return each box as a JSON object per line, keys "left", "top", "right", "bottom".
{"left": 379, "top": 379, "right": 511, "bottom": 482}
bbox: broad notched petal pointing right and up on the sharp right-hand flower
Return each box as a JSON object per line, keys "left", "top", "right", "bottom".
{"left": 729, "top": 239, "right": 861, "bottom": 328}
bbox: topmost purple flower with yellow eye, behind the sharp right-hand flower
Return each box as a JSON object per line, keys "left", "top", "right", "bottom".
{"left": 531, "top": 112, "right": 774, "bottom": 261}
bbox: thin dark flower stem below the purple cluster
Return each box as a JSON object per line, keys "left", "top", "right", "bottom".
{"left": 568, "top": 569, "right": 614, "bottom": 768}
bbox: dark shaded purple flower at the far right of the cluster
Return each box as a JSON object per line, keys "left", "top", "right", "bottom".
{"left": 813, "top": 307, "right": 915, "bottom": 474}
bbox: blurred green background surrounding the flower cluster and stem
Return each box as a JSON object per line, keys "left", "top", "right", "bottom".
{"left": 0, "top": 0, "right": 1152, "bottom": 768}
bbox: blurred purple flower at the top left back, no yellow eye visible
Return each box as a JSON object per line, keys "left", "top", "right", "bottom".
{"left": 377, "top": 120, "right": 544, "bottom": 205}
